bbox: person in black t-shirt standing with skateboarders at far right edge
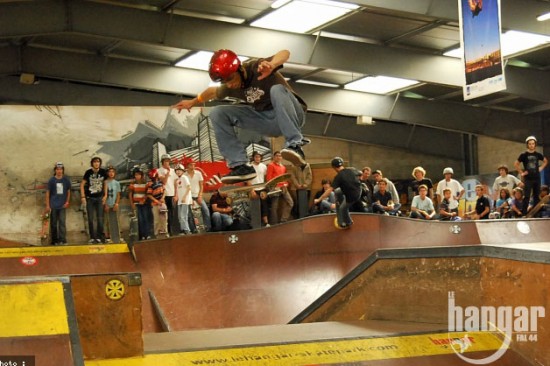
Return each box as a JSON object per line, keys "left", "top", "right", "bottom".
{"left": 514, "top": 136, "right": 548, "bottom": 215}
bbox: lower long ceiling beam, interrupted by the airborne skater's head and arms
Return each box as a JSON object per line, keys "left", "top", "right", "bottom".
{"left": 0, "top": 47, "right": 540, "bottom": 140}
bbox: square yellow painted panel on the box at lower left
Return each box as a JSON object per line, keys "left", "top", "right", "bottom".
{"left": 0, "top": 282, "right": 69, "bottom": 337}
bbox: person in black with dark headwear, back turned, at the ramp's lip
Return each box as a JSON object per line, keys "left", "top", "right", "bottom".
{"left": 313, "top": 156, "right": 367, "bottom": 229}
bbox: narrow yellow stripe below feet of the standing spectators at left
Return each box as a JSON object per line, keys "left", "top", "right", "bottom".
{"left": 0, "top": 244, "right": 128, "bottom": 258}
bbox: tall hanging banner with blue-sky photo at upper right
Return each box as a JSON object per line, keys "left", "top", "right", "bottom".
{"left": 458, "top": 0, "right": 506, "bottom": 100}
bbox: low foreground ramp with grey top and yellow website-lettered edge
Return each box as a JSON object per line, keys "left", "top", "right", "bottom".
{"left": 86, "top": 320, "right": 529, "bottom": 366}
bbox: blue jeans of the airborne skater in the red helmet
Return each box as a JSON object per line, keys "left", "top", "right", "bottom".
{"left": 210, "top": 85, "right": 305, "bottom": 168}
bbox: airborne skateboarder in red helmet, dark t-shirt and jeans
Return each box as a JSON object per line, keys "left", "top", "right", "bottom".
{"left": 174, "top": 50, "right": 309, "bottom": 184}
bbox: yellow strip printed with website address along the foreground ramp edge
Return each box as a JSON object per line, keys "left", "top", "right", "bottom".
{"left": 86, "top": 332, "right": 508, "bottom": 366}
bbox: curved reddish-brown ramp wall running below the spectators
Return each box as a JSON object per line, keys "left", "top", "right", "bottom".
{"left": 0, "top": 214, "right": 550, "bottom": 332}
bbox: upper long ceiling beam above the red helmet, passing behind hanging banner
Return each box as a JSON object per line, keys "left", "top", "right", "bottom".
{"left": 0, "top": 0, "right": 550, "bottom": 102}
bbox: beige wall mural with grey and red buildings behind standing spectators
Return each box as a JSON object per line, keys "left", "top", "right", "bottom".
{"left": 0, "top": 106, "right": 271, "bottom": 244}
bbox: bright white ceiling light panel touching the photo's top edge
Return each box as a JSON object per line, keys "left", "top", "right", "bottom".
{"left": 250, "top": 0, "right": 359, "bottom": 33}
